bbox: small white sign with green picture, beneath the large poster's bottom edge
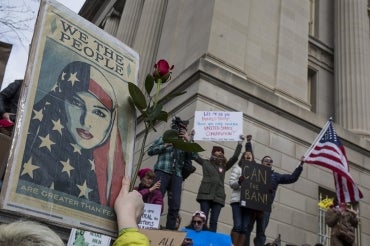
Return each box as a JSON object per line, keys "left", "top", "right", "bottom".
{"left": 67, "top": 228, "right": 111, "bottom": 246}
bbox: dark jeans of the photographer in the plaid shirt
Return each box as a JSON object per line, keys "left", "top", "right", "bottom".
{"left": 154, "top": 170, "right": 182, "bottom": 230}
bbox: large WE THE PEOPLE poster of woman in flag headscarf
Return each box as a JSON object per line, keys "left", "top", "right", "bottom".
{"left": 1, "top": 0, "right": 139, "bottom": 236}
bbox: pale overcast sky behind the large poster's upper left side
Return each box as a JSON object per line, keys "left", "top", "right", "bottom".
{"left": 0, "top": 0, "right": 85, "bottom": 89}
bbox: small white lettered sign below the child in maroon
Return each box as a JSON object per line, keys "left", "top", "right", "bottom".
{"left": 138, "top": 203, "right": 162, "bottom": 229}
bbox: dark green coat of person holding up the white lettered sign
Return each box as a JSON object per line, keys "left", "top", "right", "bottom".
{"left": 195, "top": 143, "right": 242, "bottom": 206}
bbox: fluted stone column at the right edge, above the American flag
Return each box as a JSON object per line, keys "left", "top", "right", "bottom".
{"left": 334, "top": 0, "right": 370, "bottom": 137}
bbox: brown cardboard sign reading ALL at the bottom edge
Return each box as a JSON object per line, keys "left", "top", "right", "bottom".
{"left": 140, "top": 229, "right": 186, "bottom": 246}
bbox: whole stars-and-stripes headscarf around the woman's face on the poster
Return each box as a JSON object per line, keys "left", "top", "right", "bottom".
{"left": 20, "top": 61, "right": 125, "bottom": 207}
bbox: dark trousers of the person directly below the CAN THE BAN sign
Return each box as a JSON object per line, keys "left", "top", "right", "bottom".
{"left": 244, "top": 209, "right": 271, "bottom": 246}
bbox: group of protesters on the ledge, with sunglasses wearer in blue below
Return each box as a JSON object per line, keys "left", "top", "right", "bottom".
{"left": 142, "top": 120, "right": 358, "bottom": 246}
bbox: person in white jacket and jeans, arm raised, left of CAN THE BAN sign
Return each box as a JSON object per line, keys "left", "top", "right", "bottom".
{"left": 229, "top": 135, "right": 254, "bottom": 246}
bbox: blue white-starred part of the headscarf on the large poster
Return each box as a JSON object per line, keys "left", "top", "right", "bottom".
{"left": 20, "top": 67, "right": 101, "bottom": 203}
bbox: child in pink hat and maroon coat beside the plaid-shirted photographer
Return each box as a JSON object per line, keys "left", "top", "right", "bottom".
{"left": 134, "top": 168, "right": 163, "bottom": 212}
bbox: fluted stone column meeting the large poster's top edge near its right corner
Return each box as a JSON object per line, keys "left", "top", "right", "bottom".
{"left": 116, "top": 0, "right": 144, "bottom": 47}
